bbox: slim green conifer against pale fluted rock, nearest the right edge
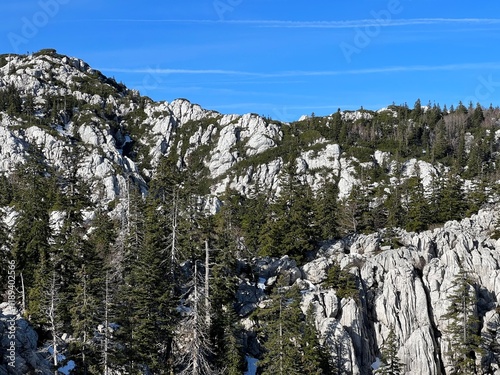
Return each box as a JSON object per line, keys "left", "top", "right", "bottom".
{"left": 443, "top": 269, "right": 481, "bottom": 374}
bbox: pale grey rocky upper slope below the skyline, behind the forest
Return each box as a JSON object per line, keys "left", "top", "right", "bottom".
{"left": 0, "top": 50, "right": 448, "bottom": 206}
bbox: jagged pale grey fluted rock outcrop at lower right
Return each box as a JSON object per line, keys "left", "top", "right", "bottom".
{"left": 239, "top": 206, "right": 500, "bottom": 375}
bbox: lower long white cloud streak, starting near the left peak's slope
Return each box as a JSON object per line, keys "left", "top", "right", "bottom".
{"left": 100, "top": 62, "right": 500, "bottom": 78}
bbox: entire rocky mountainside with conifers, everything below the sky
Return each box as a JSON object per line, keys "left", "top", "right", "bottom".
{"left": 0, "top": 50, "right": 500, "bottom": 374}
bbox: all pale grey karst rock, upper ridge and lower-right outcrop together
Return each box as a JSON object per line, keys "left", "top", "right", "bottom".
{"left": 0, "top": 52, "right": 500, "bottom": 375}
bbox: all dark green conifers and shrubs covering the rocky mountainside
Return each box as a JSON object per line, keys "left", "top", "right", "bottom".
{"left": 0, "top": 49, "right": 500, "bottom": 375}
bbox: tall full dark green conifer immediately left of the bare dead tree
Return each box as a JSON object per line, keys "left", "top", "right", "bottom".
{"left": 115, "top": 192, "right": 176, "bottom": 374}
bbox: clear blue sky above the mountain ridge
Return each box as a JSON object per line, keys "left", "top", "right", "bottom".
{"left": 0, "top": 0, "right": 500, "bottom": 121}
